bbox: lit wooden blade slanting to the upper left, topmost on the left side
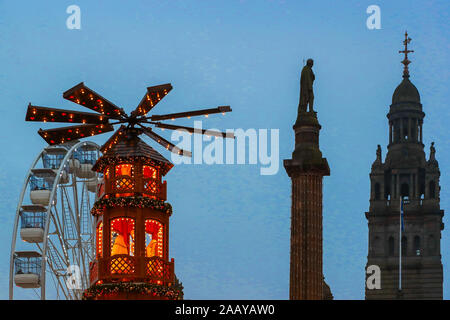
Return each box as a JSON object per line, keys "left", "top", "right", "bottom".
{"left": 63, "top": 82, "right": 125, "bottom": 119}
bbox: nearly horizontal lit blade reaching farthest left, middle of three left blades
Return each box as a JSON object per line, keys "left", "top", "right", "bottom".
{"left": 25, "top": 103, "right": 109, "bottom": 124}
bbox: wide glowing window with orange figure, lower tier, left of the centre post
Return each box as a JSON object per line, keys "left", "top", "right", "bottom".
{"left": 111, "top": 218, "right": 135, "bottom": 256}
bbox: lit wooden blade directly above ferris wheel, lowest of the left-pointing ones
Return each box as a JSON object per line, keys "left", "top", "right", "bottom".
{"left": 38, "top": 123, "right": 114, "bottom": 145}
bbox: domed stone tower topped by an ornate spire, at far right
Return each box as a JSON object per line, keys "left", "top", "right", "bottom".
{"left": 365, "top": 34, "right": 444, "bottom": 299}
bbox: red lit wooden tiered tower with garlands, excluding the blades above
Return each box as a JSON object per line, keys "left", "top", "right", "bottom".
{"left": 84, "top": 130, "right": 183, "bottom": 300}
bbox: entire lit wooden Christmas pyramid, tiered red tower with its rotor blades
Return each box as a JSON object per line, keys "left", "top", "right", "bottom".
{"left": 26, "top": 83, "right": 234, "bottom": 299}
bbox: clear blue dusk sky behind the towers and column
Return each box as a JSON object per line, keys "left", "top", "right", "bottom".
{"left": 0, "top": 0, "right": 450, "bottom": 299}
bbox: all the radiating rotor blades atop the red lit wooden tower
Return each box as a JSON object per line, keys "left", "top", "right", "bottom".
{"left": 25, "top": 82, "right": 234, "bottom": 156}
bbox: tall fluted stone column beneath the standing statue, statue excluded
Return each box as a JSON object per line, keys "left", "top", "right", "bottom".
{"left": 284, "top": 63, "right": 332, "bottom": 300}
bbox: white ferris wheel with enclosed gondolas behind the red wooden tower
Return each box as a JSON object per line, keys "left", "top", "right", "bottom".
{"left": 9, "top": 141, "right": 102, "bottom": 299}
